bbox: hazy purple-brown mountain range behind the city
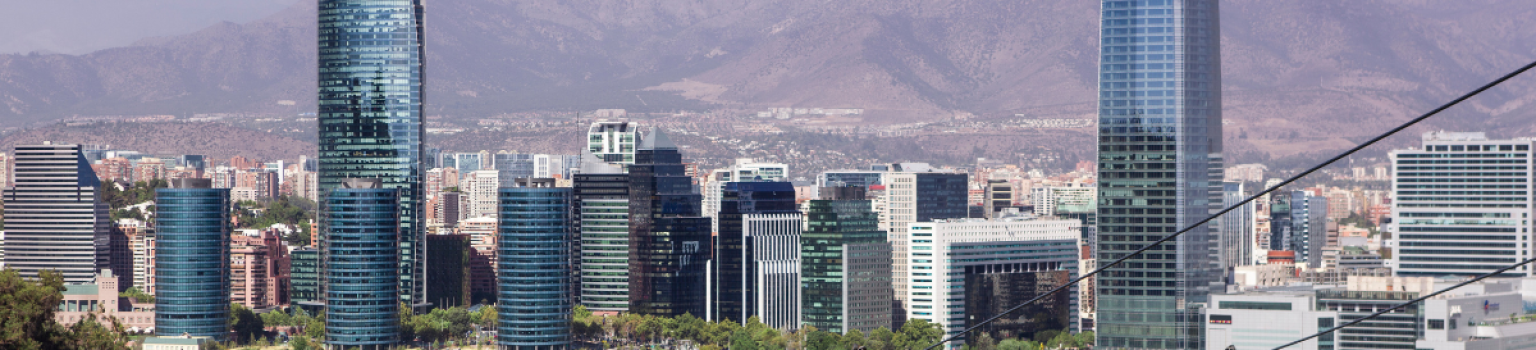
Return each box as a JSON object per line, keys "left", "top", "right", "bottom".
{"left": 0, "top": 0, "right": 1536, "bottom": 157}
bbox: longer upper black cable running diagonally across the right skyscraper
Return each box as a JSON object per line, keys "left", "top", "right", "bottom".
{"left": 925, "top": 61, "right": 1536, "bottom": 350}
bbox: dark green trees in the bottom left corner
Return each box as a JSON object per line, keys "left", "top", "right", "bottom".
{"left": 0, "top": 269, "right": 129, "bottom": 350}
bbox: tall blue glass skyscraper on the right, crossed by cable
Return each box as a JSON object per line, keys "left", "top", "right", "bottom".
{"left": 1097, "top": 0, "right": 1221, "bottom": 348}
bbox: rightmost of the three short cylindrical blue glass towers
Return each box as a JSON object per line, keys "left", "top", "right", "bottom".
{"left": 496, "top": 178, "right": 571, "bottom": 350}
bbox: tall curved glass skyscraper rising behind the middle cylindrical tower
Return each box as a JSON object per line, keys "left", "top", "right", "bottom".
{"left": 318, "top": 0, "right": 425, "bottom": 304}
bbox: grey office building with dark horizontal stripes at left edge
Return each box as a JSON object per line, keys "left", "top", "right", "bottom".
{"left": 3, "top": 143, "right": 111, "bottom": 284}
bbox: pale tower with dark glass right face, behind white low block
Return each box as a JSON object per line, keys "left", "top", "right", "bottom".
{"left": 880, "top": 163, "right": 969, "bottom": 311}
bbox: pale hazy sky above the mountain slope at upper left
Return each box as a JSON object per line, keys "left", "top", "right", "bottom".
{"left": 0, "top": 0, "right": 298, "bottom": 54}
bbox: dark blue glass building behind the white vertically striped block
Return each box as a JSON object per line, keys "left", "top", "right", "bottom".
{"left": 713, "top": 183, "right": 800, "bottom": 324}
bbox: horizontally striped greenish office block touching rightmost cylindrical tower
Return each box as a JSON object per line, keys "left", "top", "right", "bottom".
{"left": 571, "top": 154, "right": 630, "bottom": 313}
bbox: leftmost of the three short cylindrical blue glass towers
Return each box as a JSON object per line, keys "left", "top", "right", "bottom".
{"left": 155, "top": 178, "right": 233, "bottom": 339}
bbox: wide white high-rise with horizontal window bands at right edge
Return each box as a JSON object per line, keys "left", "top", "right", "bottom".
{"left": 1384, "top": 132, "right": 1536, "bottom": 276}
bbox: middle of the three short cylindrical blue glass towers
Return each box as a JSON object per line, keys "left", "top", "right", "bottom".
{"left": 323, "top": 178, "right": 401, "bottom": 348}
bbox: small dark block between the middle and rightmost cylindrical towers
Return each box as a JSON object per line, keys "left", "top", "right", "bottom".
{"left": 427, "top": 235, "right": 466, "bottom": 307}
